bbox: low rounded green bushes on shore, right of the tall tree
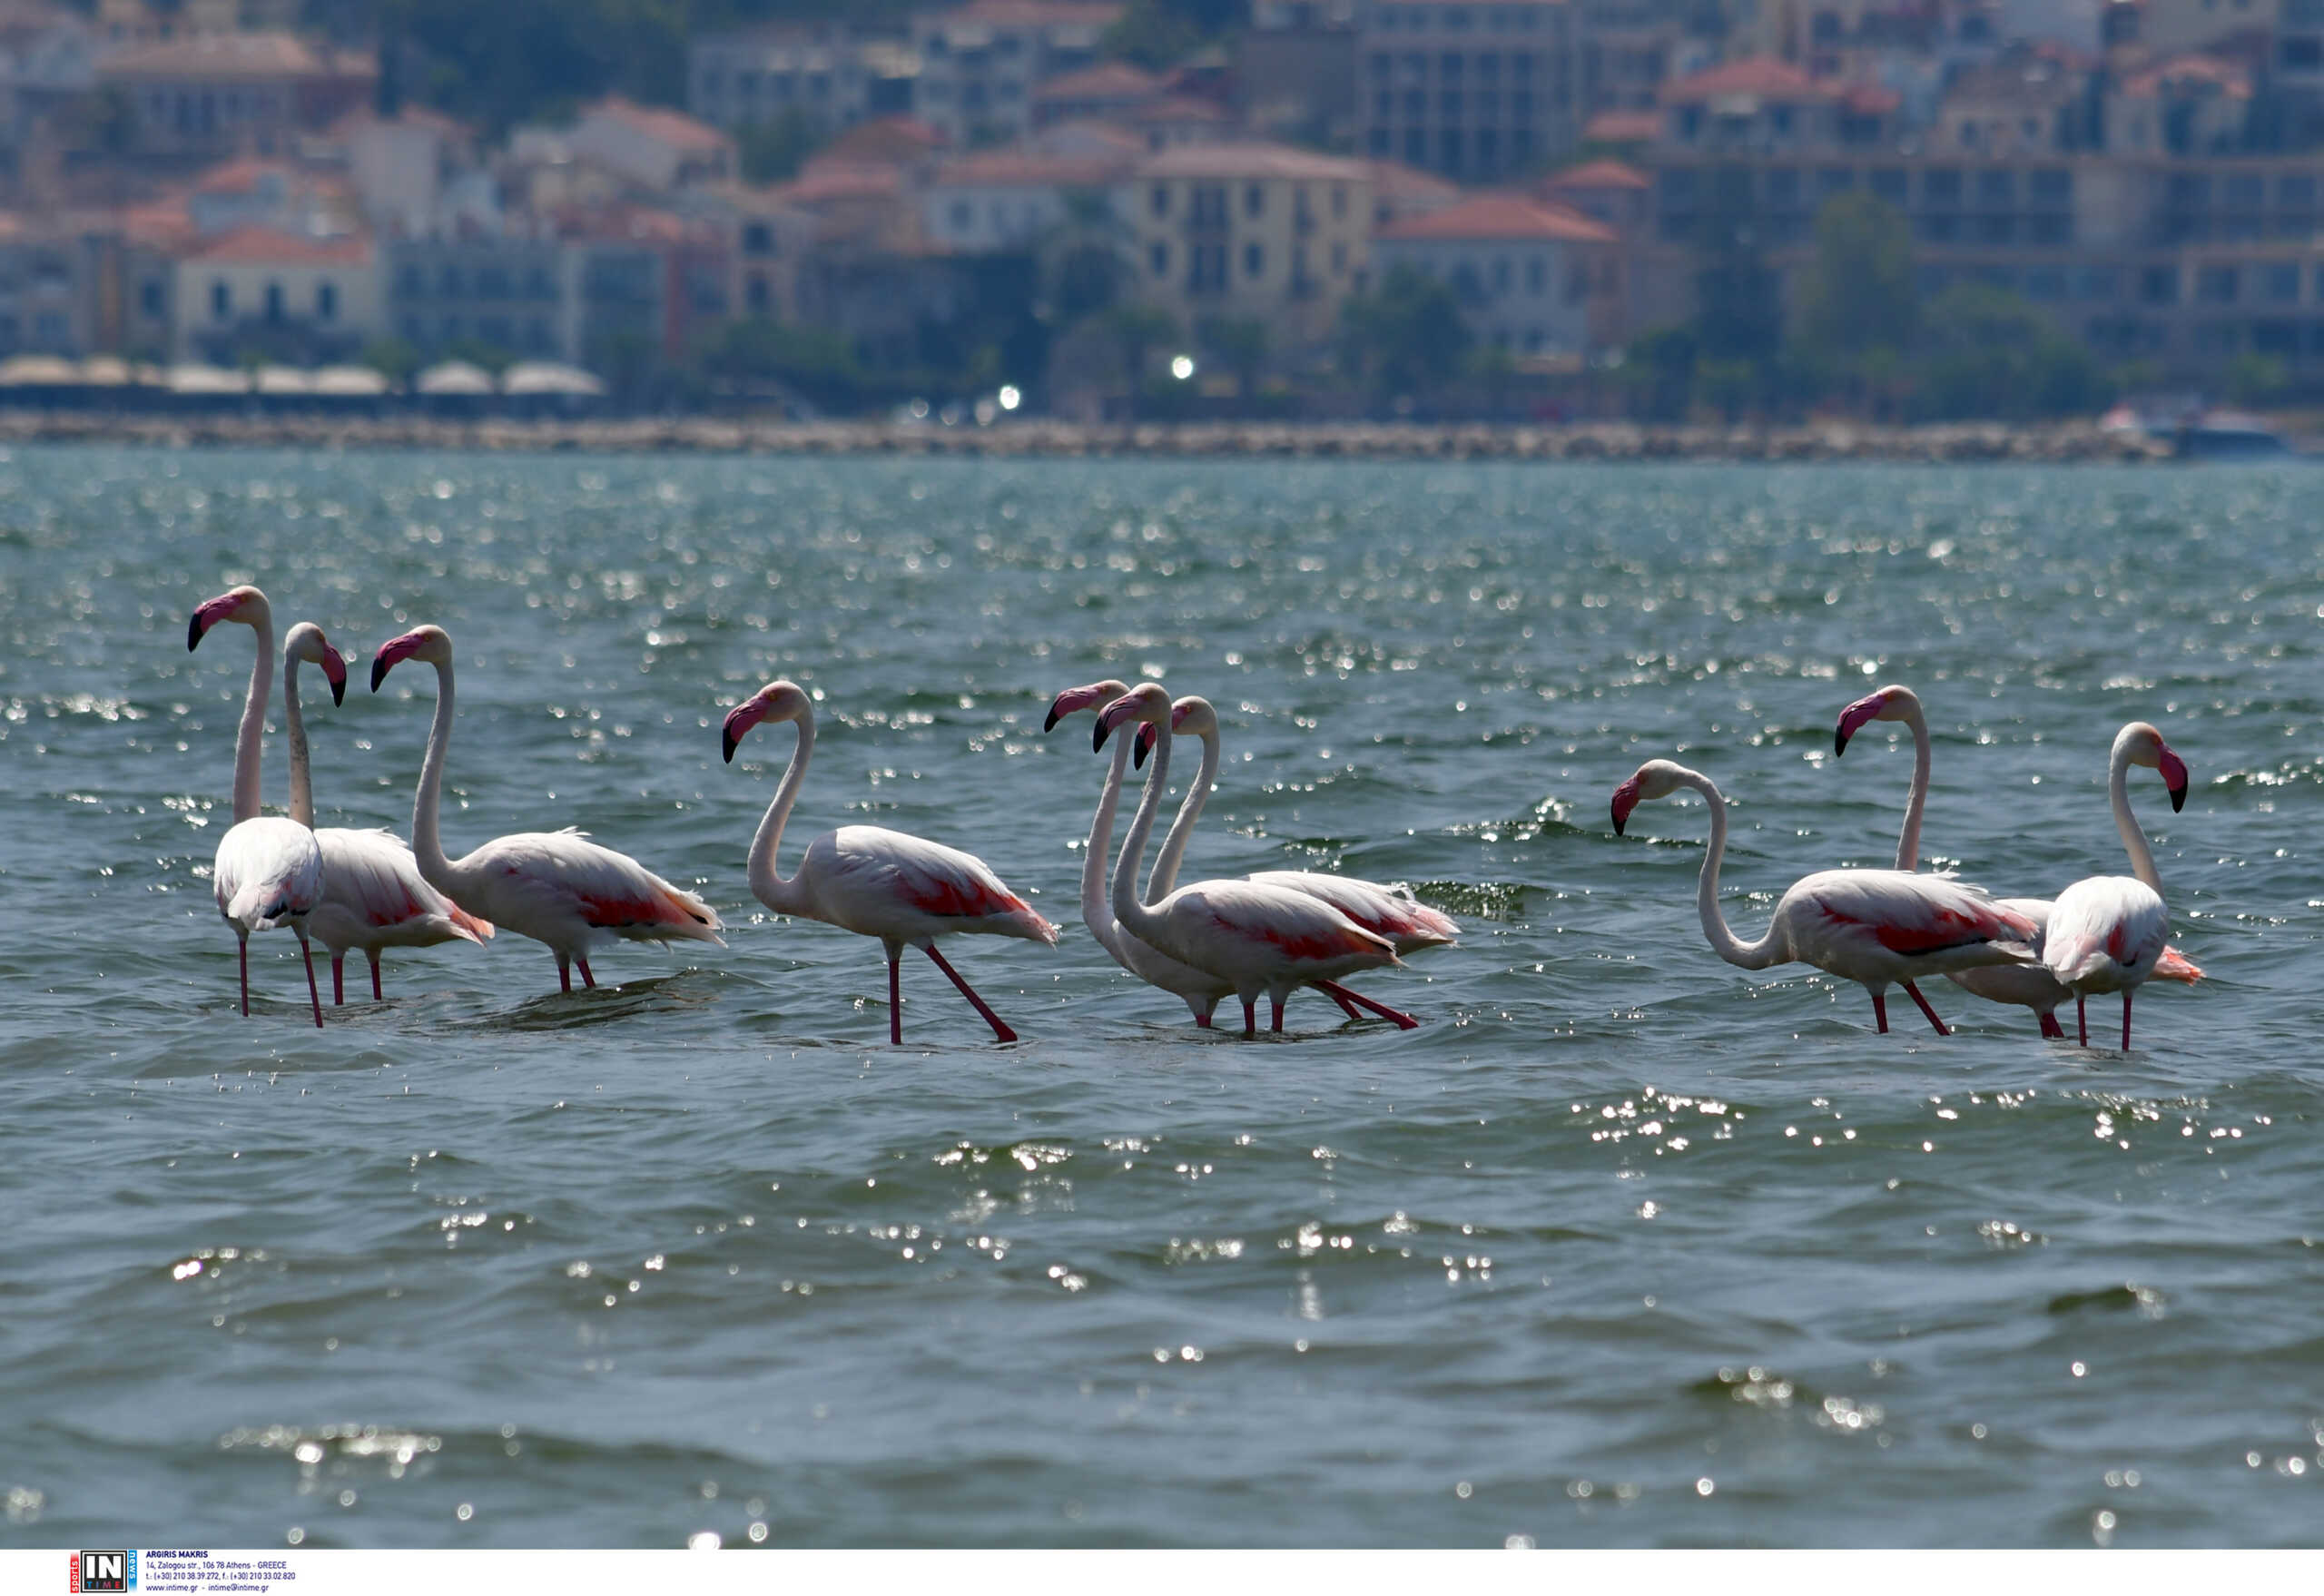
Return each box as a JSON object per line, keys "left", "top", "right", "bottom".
{"left": 1917, "top": 283, "right": 2112, "bottom": 420}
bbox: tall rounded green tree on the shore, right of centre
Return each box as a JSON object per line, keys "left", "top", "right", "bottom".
{"left": 1794, "top": 192, "right": 1920, "bottom": 407}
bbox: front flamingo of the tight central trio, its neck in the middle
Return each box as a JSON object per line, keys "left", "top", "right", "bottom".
{"left": 1092, "top": 683, "right": 1399, "bottom": 1036}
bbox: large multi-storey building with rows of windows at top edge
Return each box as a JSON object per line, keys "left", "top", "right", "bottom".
{"left": 1354, "top": 0, "right": 1581, "bottom": 183}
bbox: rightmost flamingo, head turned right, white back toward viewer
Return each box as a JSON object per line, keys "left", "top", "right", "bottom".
{"left": 2043, "top": 720, "right": 2187, "bottom": 1052}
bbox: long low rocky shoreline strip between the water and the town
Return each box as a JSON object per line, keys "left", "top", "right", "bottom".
{"left": 0, "top": 409, "right": 2212, "bottom": 465}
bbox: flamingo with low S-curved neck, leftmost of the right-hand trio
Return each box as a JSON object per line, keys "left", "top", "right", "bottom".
{"left": 1613, "top": 760, "right": 2036, "bottom": 1036}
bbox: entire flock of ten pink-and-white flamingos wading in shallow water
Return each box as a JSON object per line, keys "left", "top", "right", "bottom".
{"left": 186, "top": 586, "right": 2203, "bottom": 1048}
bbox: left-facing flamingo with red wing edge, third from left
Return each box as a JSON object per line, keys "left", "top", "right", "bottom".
{"left": 372, "top": 627, "right": 725, "bottom": 992}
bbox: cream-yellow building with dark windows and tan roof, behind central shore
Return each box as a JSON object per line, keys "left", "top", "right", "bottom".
{"left": 1113, "top": 144, "right": 1371, "bottom": 344}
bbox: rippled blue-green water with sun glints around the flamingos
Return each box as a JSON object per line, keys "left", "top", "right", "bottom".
{"left": 0, "top": 450, "right": 2324, "bottom": 1545}
